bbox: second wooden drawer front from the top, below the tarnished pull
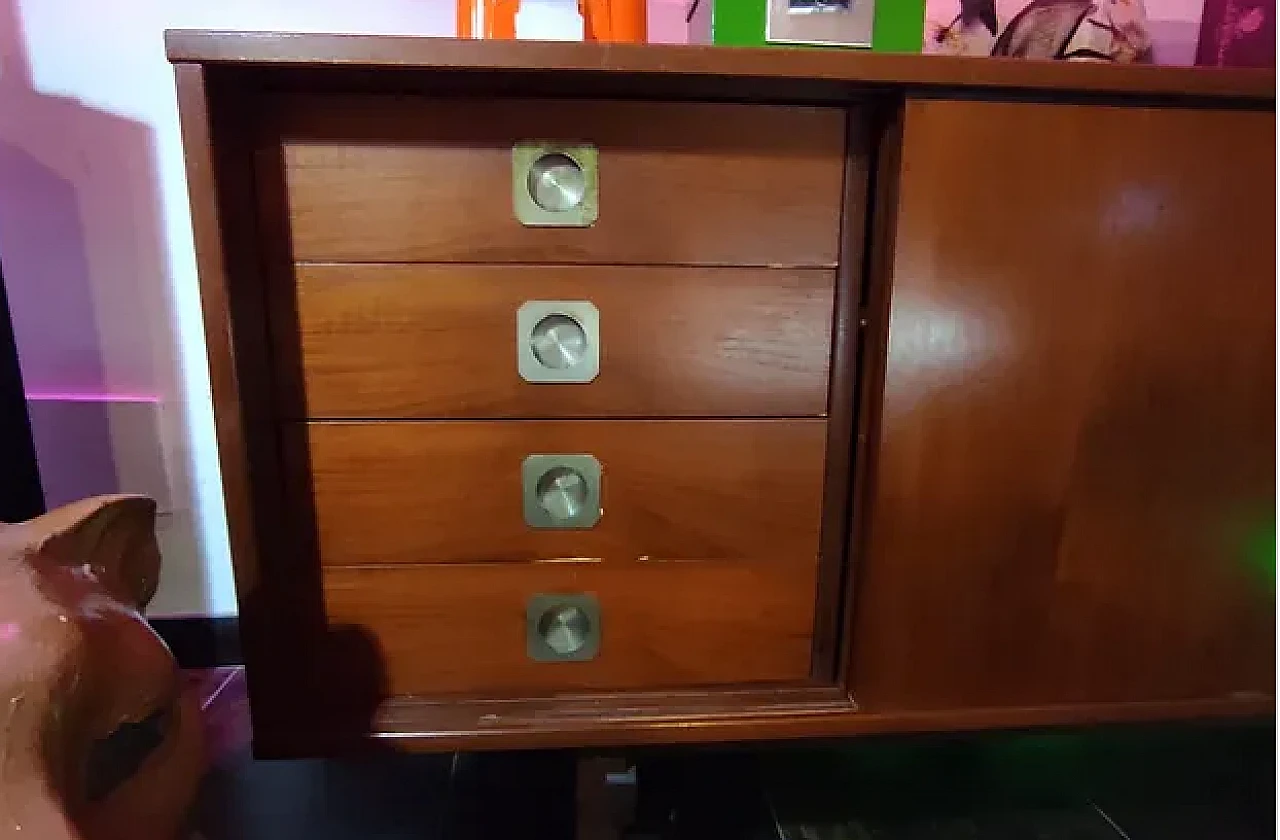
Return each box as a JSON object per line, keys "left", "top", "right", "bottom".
{"left": 280, "top": 265, "right": 833, "bottom": 417}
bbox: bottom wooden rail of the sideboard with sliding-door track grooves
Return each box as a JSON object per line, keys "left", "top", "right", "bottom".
{"left": 256, "top": 689, "right": 1275, "bottom": 758}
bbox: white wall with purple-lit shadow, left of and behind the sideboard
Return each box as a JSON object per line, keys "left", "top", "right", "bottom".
{"left": 0, "top": 0, "right": 456, "bottom": 615}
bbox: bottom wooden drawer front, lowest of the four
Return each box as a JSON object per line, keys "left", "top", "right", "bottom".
{"left": 324, "top": 563, "right": 815, "bottom": 697}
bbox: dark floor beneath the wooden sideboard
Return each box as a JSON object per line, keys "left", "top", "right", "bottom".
{"left": 180, "top": 670, "right": 1276, "bottom": 840}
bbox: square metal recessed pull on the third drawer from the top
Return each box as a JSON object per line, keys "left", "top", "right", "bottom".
{"left": 521, "top": 455, "right": 602, "bottom": 529}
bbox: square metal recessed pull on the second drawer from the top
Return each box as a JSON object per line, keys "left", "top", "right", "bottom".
{"left": 516, "top": 301, "right": 600, "bottom": 383}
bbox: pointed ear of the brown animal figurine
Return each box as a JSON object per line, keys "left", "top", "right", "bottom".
{"left": 27, "top": 496, "right": 160, "bottom": 610}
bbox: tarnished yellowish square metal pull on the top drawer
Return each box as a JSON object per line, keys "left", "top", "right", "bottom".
{"left": 511, "top": 143, "right": 599, "bottom": 228}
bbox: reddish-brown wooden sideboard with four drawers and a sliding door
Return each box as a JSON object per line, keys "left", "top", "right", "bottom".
{"left": 168, "top": 32, "right": 1276, "bottom": 755}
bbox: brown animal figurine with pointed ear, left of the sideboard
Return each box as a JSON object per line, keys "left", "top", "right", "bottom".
{"left": 0, "top": 496, "right": 204, "bottom": 840}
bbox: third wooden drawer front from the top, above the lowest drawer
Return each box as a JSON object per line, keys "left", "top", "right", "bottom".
{"left": 305, "top": 420, "right": 827, "bottom": 563}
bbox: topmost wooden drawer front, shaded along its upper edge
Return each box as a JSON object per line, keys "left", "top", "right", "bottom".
{"left": 278, "top": 96, "right": 845, "bottom": 266}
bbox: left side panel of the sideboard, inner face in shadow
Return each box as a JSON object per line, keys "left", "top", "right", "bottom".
{"left": 174, "top": 64, "right": 323, "bottom": 758}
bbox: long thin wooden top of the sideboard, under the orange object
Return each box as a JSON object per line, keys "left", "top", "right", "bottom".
{"left": 165, "top": 29, "right": 1275, "bottom": 105}
